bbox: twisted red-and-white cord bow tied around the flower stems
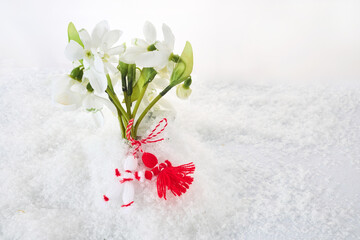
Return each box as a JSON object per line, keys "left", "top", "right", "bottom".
{"left": 126, "top": 118, "right": 167, "bottom": 157}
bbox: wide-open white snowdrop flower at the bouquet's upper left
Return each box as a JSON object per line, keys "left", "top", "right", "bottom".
{"left": 65, "top": 21, "right": 125, "bottom": 94}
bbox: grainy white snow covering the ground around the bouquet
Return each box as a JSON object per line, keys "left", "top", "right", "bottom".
{"left": 0, "top": 66, "right": 360, "bottom": 239}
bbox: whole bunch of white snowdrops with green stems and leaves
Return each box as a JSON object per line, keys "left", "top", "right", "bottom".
{"left": 53, "top": 21, "right": 193, "bottom": 138}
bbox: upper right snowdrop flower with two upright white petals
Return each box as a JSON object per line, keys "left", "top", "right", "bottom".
{"left": 121, "top": 22, "right": 175, "bottom": 70}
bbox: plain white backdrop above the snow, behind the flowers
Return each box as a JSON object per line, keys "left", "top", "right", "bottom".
{"left": 0, "top": 0, "right": 360, "bottom": 82}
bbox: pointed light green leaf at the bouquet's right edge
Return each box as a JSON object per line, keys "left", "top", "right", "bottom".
{"left": 170, "top": 42, "right": 194, "bottom": 86}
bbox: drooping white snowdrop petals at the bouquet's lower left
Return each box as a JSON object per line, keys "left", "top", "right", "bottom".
{"left": 52, "top": 75, "right": 116, "bottom": 126}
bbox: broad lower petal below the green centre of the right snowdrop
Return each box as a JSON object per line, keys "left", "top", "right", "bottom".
{"left": 135, "top": 51, "right": 170, "bottom": 69}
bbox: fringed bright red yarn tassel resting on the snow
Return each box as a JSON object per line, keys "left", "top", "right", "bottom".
{"left": 156, "top": 160, "right": 195, "bottom": 200}
